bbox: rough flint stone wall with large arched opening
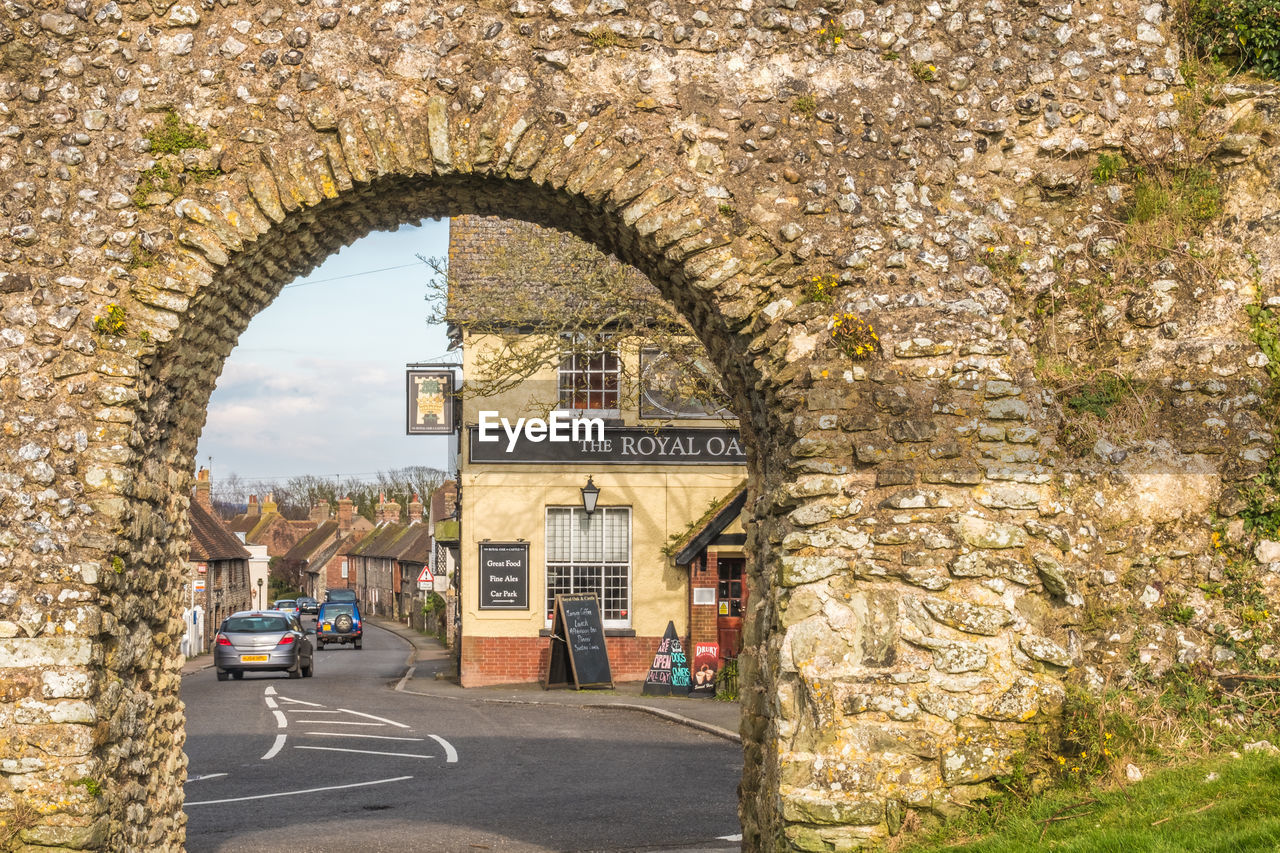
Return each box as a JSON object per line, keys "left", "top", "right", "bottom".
{"left": 0, "top": 0, "right": 1277, "bottom": 853}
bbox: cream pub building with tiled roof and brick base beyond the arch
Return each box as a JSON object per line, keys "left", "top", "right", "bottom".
{"left": 447, "top": 216, "right": 746, "bottom": 686}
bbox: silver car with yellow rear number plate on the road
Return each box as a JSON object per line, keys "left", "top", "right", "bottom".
{"left": 214, "top": 610, "right": 315, "bottom": 681}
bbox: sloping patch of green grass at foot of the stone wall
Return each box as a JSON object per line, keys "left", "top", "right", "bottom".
{"left": 897, "top": 752, "right": 1280, "bottom": 853}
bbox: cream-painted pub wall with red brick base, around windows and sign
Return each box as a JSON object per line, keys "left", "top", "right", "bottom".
{"left": 458, "top": 334, "right": 746, "bottom": 685}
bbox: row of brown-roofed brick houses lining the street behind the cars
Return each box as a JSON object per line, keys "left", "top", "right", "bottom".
{"left": 183, "top": 469, "right": 457, "bottom": 654}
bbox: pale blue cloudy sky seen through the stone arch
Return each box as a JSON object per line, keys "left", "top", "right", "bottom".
{"left": 196, "top": 220, "right": 457, "bottom": 485}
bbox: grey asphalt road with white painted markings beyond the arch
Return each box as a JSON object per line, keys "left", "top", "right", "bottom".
{"left": 182, "top": 617, "right": 742, "bottom": 853}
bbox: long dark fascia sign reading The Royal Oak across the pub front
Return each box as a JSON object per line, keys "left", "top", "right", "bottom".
{"left": 467, "top": 419, "right": 746, "bottom": 465}
